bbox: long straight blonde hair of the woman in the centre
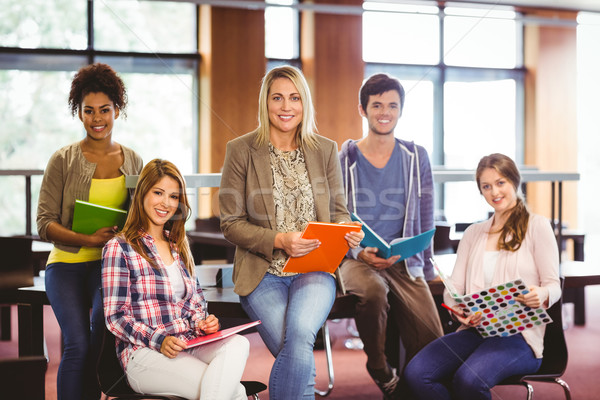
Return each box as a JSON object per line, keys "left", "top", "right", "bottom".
{"left": 255, "top": 65, "right": 319, "bottom": 148}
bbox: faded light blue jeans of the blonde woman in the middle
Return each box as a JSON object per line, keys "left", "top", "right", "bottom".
{"left": 240, "top": 272, "right": 335, "bottom": 400}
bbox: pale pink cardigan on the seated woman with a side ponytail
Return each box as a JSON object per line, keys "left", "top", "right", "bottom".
{"left": 444, "top": 214, "right": 561, "bottom": 358}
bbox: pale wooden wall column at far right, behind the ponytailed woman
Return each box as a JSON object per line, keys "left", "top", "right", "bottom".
{"left": 524, "top": 10, "right": 577, "bottom": 228}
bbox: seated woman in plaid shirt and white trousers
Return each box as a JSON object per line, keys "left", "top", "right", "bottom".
{"left": 102, "top": 159, "right": 249, "bottom": 400}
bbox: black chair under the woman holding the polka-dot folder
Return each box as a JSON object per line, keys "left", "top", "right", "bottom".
{"left": 499, "top": 290, "right": 571, "bottom": 400}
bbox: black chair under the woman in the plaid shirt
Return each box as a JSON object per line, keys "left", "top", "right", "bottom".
{"left": 96, "top": 327, "right": 267, "bottom": 400}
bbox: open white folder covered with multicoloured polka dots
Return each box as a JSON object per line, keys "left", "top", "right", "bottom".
{"left": 432, "top": 260, "right": 552, "bottom": 337}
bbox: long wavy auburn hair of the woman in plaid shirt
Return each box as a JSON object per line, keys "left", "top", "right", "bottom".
{"left": 121, "top": 158, "right": 194, "bottom": 275}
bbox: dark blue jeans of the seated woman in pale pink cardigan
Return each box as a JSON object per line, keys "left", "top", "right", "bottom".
{"left": 404, "top": 329, "right": 542, "bottom": 400}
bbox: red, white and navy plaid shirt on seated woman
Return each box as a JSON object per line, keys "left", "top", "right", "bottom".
{"left": 102, "top": 233, "right": 205, "bottom": 370}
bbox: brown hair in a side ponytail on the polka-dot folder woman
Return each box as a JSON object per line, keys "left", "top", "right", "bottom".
{"left": 475, "top": 153, "right": 529, "bottom": 251}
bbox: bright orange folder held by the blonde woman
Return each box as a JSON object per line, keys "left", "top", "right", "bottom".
{"left": 283, "top": 222, "right": 361, "bottom": 273}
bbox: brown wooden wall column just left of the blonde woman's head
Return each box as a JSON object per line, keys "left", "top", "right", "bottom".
{"left": 198, "top": 5, "right": 266, "bottom": 218}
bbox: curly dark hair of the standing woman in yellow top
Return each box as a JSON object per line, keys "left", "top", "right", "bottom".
{"left": 69, "top": 63, "right": 127, "bottom": 117}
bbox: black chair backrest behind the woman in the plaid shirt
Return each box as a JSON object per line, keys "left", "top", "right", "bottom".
{"left": 96, "top": 326, "right": 135, "bottom": 395}
